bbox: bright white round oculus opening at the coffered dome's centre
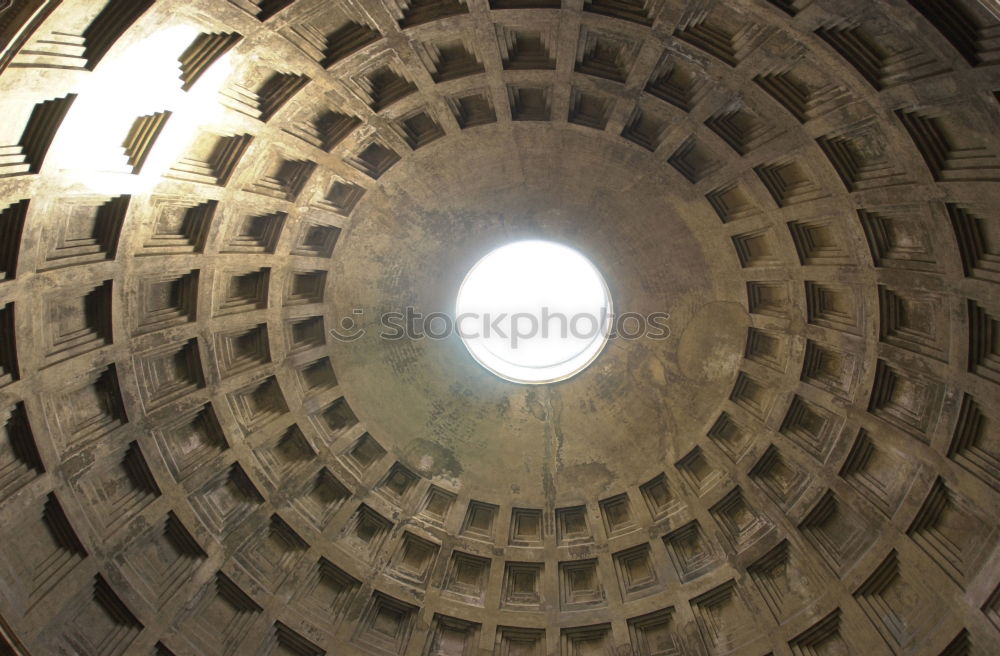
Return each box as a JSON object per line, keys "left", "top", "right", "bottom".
{"left": 455, "top": 240, "right": 612, "bottom": 384}
